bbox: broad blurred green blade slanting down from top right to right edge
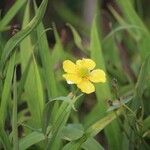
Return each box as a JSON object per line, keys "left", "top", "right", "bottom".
{"left": 117, "top": 0, "right": 150, "bottom": 61}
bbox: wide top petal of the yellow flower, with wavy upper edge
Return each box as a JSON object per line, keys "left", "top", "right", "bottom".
{"left": 76, "top": 58, "right": 96, "bottom": 70}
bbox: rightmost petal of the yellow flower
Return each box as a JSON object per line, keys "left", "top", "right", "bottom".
{"left": 89, "top": 69, "right": 106, "bottom": 83}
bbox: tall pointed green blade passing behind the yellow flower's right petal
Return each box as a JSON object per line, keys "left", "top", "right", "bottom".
{"left": 87, "top": 17, "right": 121, "bottom": 150}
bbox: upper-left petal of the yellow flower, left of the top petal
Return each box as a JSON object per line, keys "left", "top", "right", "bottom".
{"left": 63, "top": 60, "right": 76, "bottom": 73}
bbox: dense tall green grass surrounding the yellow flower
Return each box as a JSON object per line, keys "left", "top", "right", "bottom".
{"left": 0, "top": 0, "right": 150, "bottom": 150}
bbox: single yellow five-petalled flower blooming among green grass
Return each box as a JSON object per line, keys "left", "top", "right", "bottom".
{"left": 63, "top": 58, "right": 106, "bottom": 94}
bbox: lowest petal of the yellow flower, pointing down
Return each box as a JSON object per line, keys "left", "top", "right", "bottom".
{"left": 77, "top": 80, "right": 95, "bottom": 94}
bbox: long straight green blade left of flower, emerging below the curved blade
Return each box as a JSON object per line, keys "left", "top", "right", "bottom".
{"left": 34, "top": 3, "right": 58, "bottom": 98}
